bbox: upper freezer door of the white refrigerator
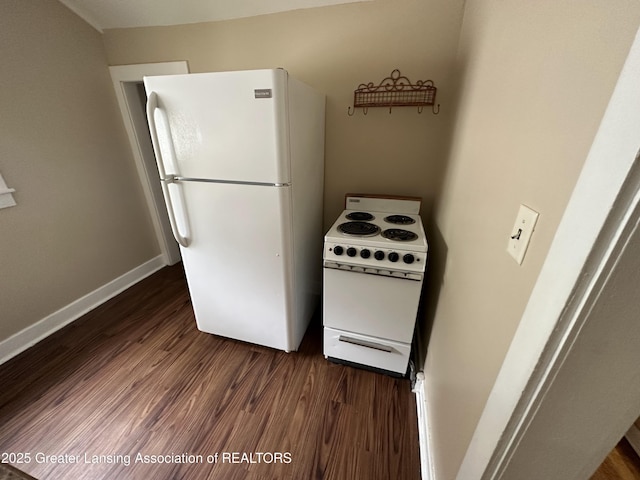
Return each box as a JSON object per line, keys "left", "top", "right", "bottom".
{"left": 144, "top": 69, "right": 290, "bottom": 184}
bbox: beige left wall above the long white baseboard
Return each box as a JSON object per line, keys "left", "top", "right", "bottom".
{"left": 0, "top": 0, "right": 159, "bottom": 340}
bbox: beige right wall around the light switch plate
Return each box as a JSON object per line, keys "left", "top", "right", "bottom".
{"left": 425, "top": 0, "right": 640, "bottom": 480}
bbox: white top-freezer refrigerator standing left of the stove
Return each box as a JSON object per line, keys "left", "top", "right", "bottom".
{"left": 144, "top": 69, "right": 325, "bottom": 351}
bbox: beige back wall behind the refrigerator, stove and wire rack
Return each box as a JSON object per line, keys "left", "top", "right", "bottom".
{"left": 104, "top": 0, "right": 463, "bottom": 227}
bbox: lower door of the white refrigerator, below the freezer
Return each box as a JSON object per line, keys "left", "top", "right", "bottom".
{"left": 177, "top": 181, "right": 297, "bottom": 351}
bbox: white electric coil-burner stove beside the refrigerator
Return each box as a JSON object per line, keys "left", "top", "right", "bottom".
{"left": 323, "top": 195, "right": 428, "bottom": 376}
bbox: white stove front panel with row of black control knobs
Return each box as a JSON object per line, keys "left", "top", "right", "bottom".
{"left": 324, "top": 243, "right": 427, "bottom": 272}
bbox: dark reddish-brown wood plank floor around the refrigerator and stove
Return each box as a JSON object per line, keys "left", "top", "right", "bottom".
{"left": 0, "top": 265, "right": 420, "bottom": 480}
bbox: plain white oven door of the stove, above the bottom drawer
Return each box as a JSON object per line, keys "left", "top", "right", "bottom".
{"left": 323, "top": 267, "right": 422, "bottom": 343}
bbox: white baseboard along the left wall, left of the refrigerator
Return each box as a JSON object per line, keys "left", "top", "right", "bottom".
{"left": 0, "top": 255, "right": 165, "bottom": 364}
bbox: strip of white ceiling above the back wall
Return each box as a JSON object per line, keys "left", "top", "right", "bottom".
{"left": 60, "top": 0, "right": 371, "bottom": 31}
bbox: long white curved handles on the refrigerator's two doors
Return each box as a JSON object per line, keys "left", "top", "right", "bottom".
{"left": 147, "top": 92, "right": 190, "bottom": 248}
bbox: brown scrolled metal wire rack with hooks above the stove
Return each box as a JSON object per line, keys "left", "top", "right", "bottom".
{"left": 347, "top": 69, "right": 440, "bottom": 117}
